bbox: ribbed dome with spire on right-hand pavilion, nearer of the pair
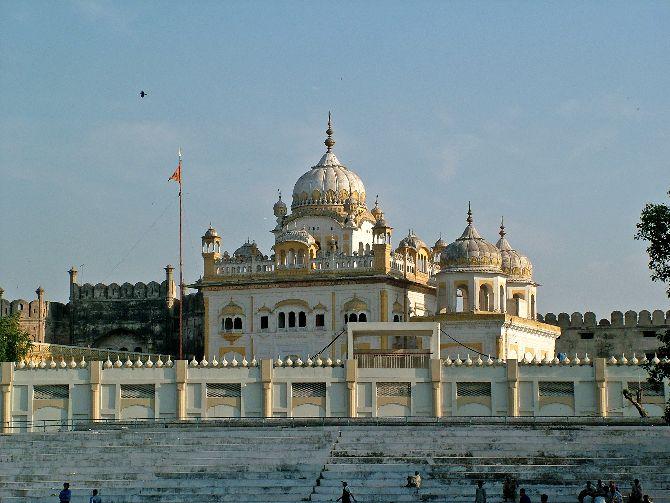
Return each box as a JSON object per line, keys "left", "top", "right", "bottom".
{"left": 440, "top": 208, "right": 502, "bottom": 273}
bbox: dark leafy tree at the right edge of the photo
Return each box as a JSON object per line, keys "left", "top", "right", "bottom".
{"left": 635, "top": 191, "right": 670, "bottom": 424}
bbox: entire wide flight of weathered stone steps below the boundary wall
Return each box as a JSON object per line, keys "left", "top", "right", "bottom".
{"left": 0, "top": 422, "right": 670, "bottom": 503}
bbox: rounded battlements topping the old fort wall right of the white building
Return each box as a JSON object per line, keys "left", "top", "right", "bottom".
{"left": 537, "top": 309, "right": 670, "bottom": 328}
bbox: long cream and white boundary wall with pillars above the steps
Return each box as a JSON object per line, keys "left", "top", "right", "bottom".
{"left": 0, "top": 356, "right": 670, "bottom": 433}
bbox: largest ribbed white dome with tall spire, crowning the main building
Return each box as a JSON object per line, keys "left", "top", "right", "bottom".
{"left": 291, "top": 114, "right": 365, "bottom": 210}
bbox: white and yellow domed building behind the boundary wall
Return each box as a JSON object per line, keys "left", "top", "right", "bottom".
{"left": 192, "top": 116, "right": 555, "bottom": 361}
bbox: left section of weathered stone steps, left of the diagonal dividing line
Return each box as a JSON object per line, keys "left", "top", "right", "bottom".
{"left": 0, "top": 427, "right": 338, "bottom": 503}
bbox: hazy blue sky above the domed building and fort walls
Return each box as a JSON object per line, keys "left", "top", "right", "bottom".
{"left": 0, "top": 0, "right": 670, "bottom": 317}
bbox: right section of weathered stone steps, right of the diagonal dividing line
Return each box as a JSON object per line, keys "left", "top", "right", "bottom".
{"left": 311, "top": 425, "right": 670, "bottom": 503}
